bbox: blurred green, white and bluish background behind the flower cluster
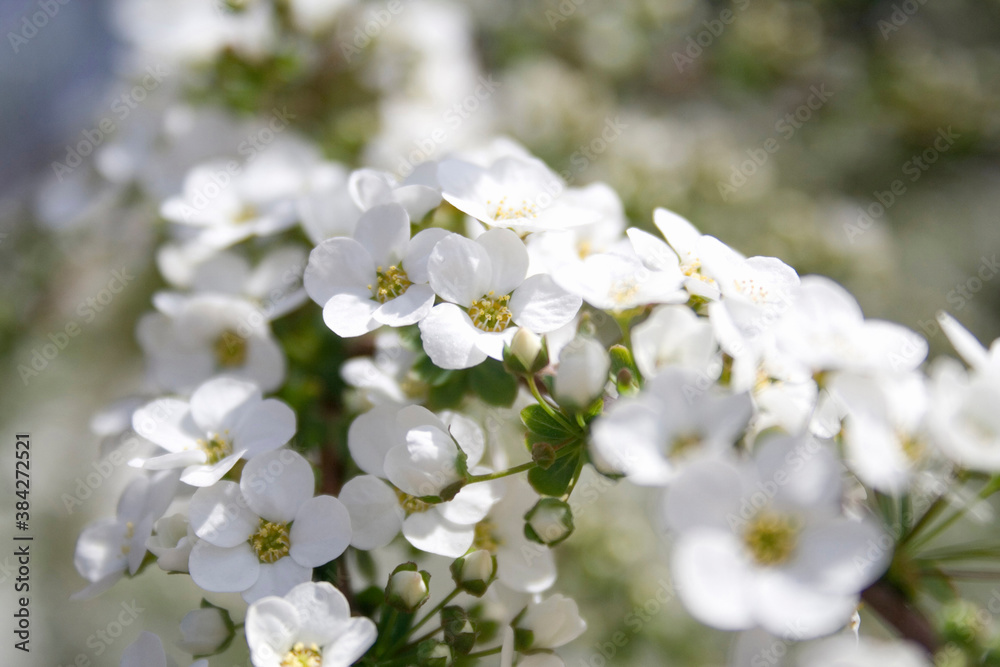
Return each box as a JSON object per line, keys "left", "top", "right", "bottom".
{"left": 0, "top": 0, "right": 1000, "bottom": 667}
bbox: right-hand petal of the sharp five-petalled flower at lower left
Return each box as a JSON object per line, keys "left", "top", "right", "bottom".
{"left": 289, "top": 496, "right": 351, "bottom": 567}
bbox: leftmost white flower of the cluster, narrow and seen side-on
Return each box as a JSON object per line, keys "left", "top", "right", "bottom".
{"left": 73, "top": 471, "right": 177, "bottom": 600}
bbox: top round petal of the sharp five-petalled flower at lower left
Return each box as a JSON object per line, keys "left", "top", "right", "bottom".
{"left": 240, "top": 449, "right": 316, "bottom": 523}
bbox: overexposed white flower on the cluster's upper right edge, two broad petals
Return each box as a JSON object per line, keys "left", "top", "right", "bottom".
{"left": 774, "top": 276, "right": 927, "bottom": 377}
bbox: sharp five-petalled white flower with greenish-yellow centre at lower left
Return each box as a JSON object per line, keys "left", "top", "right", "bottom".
{"left": 189, "top": 449, "right": 351, "bottom": 602}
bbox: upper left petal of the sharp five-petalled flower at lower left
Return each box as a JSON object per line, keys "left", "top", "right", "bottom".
{"left": 188, "top": 482, "right": 260, "bottom": 547}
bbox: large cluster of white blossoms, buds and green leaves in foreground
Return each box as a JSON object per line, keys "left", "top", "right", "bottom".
{"left": 60, "top": 7, "right": 1000, "bottom": 667}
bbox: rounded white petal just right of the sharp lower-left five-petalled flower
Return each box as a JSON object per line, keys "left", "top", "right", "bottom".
{"left": 340, "top": 475, "right": 405, "bottom": 551}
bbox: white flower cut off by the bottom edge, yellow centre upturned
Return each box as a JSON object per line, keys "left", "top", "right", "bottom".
{"left": 246, "top": 582, "right": 378, "bottom": 667}
